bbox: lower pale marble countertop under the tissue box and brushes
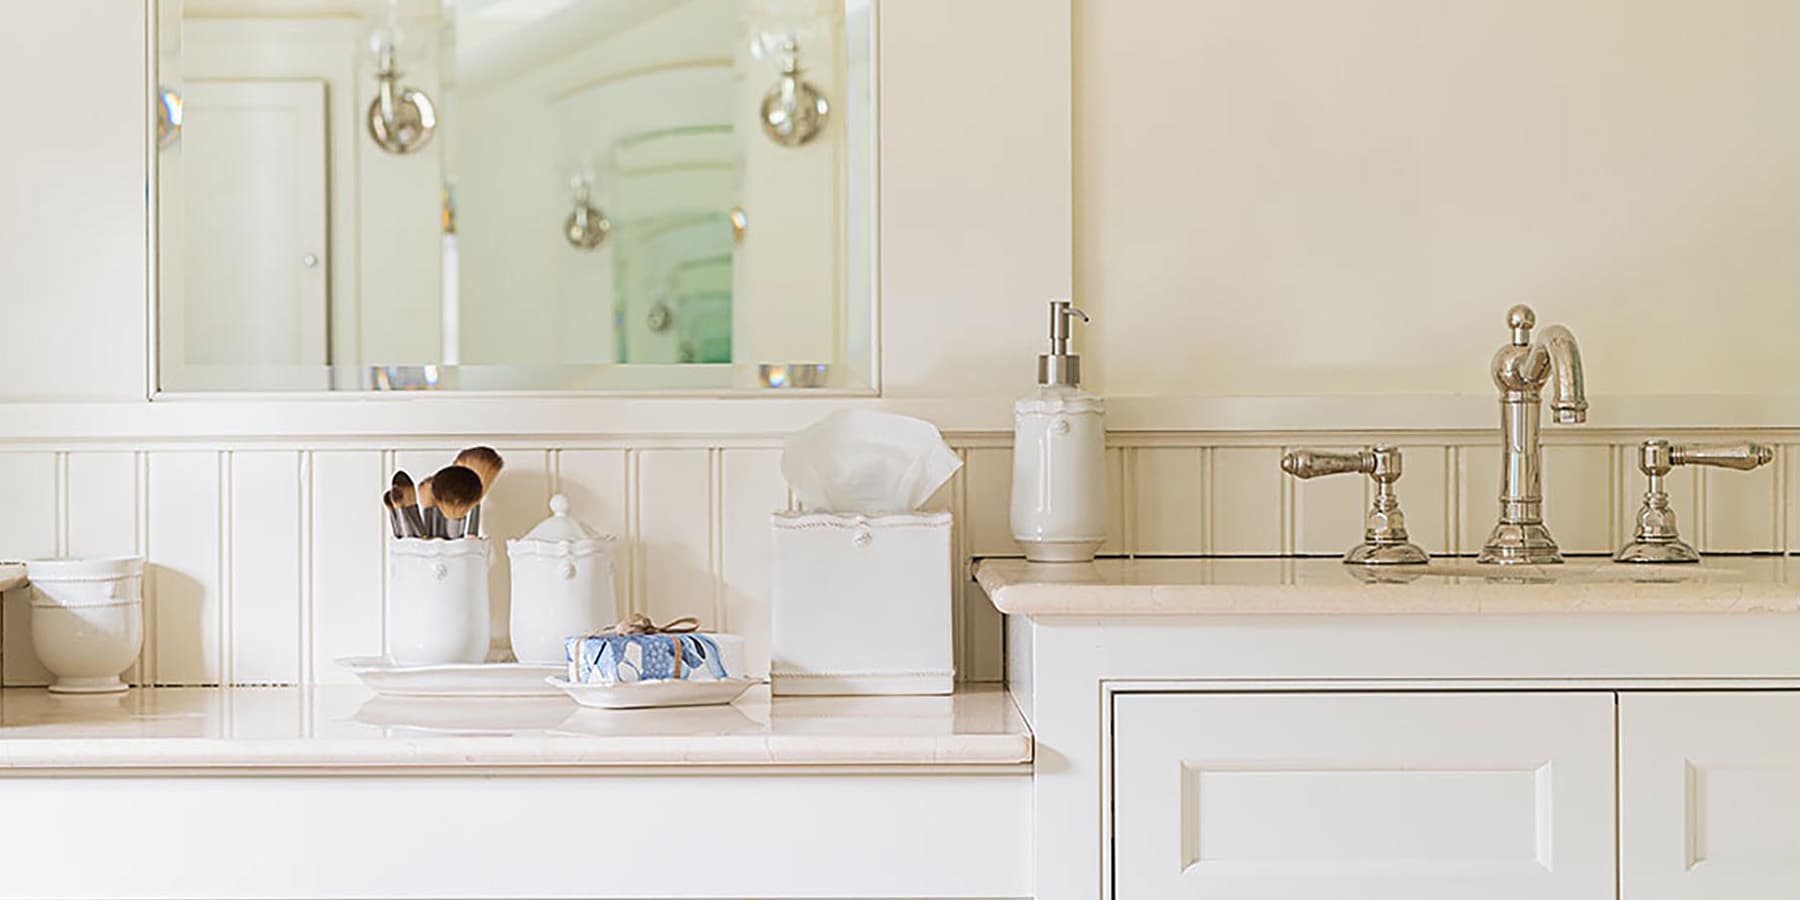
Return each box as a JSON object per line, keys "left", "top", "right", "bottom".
{"left": 0, "top": 686, "right": 1031, "bottom": 774}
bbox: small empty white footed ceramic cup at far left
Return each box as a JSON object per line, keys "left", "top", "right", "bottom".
{"left": 25, "top": 556, "right": 144, "bottom": 693}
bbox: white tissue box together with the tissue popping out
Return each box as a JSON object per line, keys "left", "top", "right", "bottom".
{"left": 770, "top": 410, "right": 963, "bottom": 695}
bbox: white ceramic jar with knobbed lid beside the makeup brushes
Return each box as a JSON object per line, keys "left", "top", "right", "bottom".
{"left": 506, "top": 493, "right": 619, "bottom": 664}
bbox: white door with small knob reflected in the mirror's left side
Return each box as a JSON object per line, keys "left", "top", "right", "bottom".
{"left": 164, "top": 81, "right": 329, "bottom": 389}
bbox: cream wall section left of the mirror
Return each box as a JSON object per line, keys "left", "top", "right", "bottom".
{"left": 0, "top": 0, "right": 149, "bottom": 401}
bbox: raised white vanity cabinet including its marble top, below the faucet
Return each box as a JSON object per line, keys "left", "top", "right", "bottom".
{"left": 976, "top": 558, "right": 1800, "bottom": 900}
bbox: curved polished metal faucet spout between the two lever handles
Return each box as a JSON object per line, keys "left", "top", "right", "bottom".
{"left": 1476, "top": 304, "right": 1588, "bottom": 565}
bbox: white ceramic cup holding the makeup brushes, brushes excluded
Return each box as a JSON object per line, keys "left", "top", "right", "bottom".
{"left": 387, "top": 538, "right": 491, "bottom": 666}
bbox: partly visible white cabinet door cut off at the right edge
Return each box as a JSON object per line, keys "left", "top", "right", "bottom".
{"left": 1618, "top": 691, "right": 1800, "bottom": 900}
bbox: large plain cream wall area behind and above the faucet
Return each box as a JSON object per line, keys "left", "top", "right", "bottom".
{"left": 1075, "top": 0, "right": 1800, "bottom": 396}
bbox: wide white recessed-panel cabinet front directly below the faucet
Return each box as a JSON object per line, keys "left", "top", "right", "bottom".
{"left": 1112, "top": 693, "right": 1616, "bottom": 900}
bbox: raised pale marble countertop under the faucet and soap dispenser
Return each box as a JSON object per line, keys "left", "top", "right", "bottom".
{"left": 976, "top": 556, "right": 1800, "bottom": 616}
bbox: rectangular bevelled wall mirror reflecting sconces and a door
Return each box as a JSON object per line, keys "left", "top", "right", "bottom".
{"left": 151, "top": 0, "right": 877, "bottom": 394}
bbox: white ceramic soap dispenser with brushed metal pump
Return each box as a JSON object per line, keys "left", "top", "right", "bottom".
{"left": 1012, "top": 301, "right": 1107, "bottom": 562}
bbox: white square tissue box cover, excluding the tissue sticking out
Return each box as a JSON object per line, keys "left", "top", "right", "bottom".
{"left": 770, "top": 513, "right": 956, "bottom": 695}
